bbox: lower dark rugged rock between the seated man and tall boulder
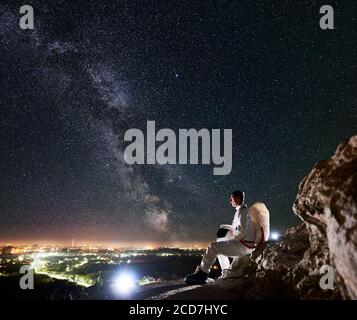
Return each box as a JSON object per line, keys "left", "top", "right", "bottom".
{"left": 252, "top": 223, "right": 334, "bottom": 299}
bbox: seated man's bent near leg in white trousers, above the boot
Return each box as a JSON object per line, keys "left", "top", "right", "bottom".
{"left": 200, "top": 240, "right": 252, "bottom": 273}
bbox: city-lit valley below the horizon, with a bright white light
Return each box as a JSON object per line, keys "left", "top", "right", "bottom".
{"left": 0, "top": 243, "right": 203, "bottom": 292}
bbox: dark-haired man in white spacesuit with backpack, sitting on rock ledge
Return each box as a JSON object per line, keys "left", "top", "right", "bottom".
{"left": 185, "top": 190, "right": 269, "bottom": 284}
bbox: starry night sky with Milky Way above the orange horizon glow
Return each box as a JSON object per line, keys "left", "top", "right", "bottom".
{"left": 0, "top": 0, "right": 357, "bottom": 244}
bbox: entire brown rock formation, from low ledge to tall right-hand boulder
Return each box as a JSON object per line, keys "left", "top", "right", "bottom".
{"left": 152, "top": 136, "right": 357, "bottom": 299}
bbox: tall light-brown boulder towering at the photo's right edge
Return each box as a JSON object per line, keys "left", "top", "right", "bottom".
{"left": 293, "top": 136, "right": 357, "bottom": 299}
